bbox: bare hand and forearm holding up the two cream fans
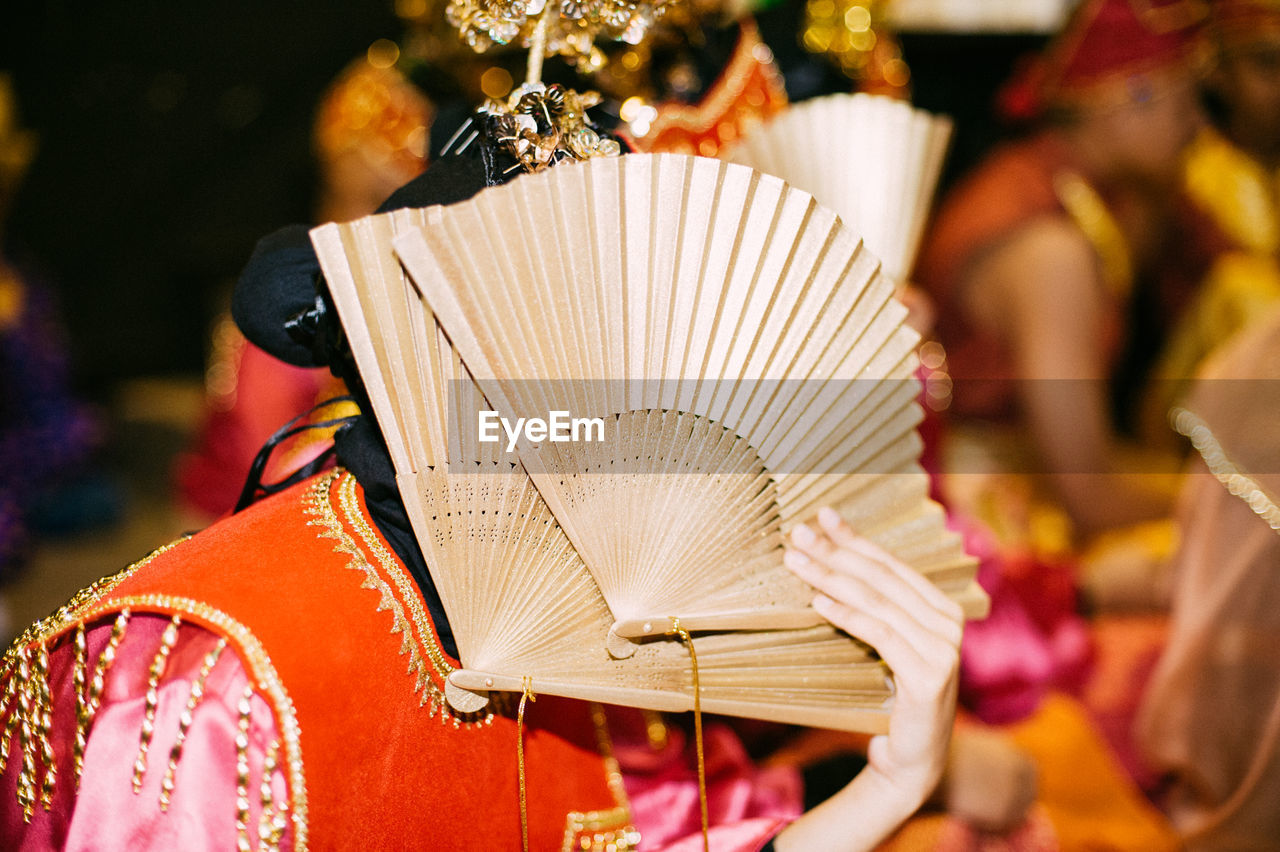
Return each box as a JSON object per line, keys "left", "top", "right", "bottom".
{"left": 774, "top": 509, "right": 964, "bottom": 852}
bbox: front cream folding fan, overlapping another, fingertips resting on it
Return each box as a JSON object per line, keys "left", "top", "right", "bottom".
{"left": 393, "top": 155, "right": 986, "bottom": 652}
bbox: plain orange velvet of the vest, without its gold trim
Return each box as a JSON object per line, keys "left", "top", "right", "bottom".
{"left": 96, "top": 473, "right": 618, "bottom": 849}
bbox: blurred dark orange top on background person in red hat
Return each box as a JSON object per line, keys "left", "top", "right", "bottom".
{"left": 915, "top": 133, "right": 1121, "bottom": 420}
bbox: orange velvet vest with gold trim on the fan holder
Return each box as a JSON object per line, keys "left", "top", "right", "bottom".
{"left": 8, "top": 472, "right": 637, "bottom": 851}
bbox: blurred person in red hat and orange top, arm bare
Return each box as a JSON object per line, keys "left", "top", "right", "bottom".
{"left": 918, "top": 0, "right": 1202, "bottom": 540}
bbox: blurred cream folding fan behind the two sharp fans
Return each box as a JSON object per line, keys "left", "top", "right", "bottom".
{"left": 721, "top": 93, "right": 951, "bottom": 281}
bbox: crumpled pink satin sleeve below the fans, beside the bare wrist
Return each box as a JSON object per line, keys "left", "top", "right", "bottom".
{"left": 609, "top": 707, "right": 804, "bottom": 852}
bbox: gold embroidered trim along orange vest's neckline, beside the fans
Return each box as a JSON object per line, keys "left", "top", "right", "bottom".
{"left": 306, "top": 471, "right": 493, "bottom": 728}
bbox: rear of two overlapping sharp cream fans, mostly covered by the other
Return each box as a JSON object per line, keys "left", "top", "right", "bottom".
{"left": 312, "top": 207, "right": 916, "bottom": 730}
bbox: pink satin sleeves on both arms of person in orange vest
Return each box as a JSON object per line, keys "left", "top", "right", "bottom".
{"left": 0, "top": 614, "right": 803, "bottom": 852}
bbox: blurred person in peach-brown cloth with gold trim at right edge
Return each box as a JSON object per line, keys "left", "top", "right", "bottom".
{"left": 1137, "top": 308, "right": 1280, "bottom": 851}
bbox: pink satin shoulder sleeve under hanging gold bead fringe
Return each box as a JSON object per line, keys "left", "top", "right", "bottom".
{"left": 0, "top": 614, "right": 292, "bottom": 852}
